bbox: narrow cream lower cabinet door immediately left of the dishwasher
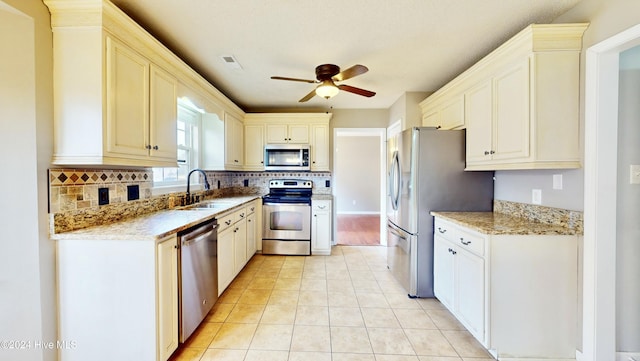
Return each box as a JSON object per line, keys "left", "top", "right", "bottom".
{"left": 156, "top": 237, "right": 178, "bottom": 360}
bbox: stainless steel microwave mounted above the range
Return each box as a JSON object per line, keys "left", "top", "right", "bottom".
{"left": 264, "top": 144, "right": 311, "bottom": 171}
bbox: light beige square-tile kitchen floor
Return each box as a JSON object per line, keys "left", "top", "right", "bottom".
{"left": 172, "top": 246, "right": 493, "bottom": 361}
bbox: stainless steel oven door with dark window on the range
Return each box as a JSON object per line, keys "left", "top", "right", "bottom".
{"left": 262, "top": 203, "right": 311, "bottom": 241}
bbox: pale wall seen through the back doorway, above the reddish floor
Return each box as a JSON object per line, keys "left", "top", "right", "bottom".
{"left": 333, "top": 133, "right": 381, "bottom": 214}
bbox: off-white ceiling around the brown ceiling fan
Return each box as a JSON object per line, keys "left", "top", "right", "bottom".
{"left": 112, "top": 0, "right": 580, "bottom": 111}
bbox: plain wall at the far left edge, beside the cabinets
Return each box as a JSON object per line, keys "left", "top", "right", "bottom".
{"left": 0, "top": 0, "right": 57, "bottom": 361}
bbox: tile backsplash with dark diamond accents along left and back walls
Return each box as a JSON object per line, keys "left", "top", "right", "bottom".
{"left": 49, "top": 169, "right": 331, "bottom": 233}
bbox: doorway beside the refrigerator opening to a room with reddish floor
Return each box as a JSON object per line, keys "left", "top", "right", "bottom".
{"left": 333, "top": 128, "right": 386, "bottom": 246}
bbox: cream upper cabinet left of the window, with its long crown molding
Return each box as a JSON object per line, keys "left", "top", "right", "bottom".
{"left": 45, "top": 0, "right": 244, "bottom": 169}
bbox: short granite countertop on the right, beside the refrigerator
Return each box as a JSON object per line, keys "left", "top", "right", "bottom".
{"left": 431, "top": 212, "right": 582, "bottom": 235}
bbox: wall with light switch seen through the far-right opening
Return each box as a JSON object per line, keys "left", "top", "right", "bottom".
{"left": 616, "top": 46, "right": 640, "bottom": 352}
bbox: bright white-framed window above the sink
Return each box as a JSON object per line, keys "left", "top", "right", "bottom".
{"left": 153, "top": 100, "right": 202, "bottom": 187}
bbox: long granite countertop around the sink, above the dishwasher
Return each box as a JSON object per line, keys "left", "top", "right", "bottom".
{"left": 51, "top": 196, "right": 260, "bottom": 241}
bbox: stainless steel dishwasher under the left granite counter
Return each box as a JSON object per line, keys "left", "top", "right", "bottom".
{"left": 178, "top": 220, "right": 218, "bottom": 343}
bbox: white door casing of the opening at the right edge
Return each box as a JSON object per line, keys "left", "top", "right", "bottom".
{"left": 579, "top": 25, "right": 640, "bottom": 361}
